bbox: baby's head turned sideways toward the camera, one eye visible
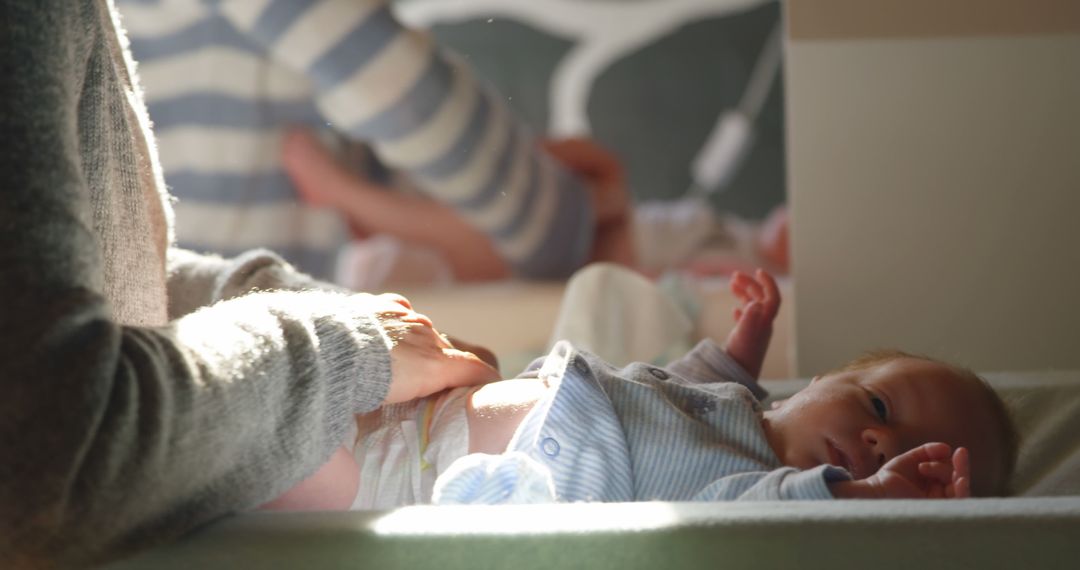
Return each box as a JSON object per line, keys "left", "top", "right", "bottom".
{"left": 764, "top": 351, "right": 1017, "bottom": 497}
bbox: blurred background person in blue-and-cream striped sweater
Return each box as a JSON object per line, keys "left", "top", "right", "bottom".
{"left": 118, "top": 0, "right": 630, "bottom": 280}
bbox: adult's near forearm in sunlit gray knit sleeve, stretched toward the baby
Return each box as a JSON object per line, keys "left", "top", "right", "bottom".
{"left": 0, "top": 287, "right": 389, "bottom": 558}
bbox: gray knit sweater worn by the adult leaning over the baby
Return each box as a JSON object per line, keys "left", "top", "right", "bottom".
{"left": 0, "top": 0, "right": 390, "bottom": 568}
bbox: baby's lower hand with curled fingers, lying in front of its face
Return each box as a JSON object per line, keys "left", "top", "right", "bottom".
{"left": 829, "top": 444, "right": 971, "bottom": 499}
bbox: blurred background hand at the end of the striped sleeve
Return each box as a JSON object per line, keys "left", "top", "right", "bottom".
{"left": 544, "top": 138, "right": 636, "bottom": 267}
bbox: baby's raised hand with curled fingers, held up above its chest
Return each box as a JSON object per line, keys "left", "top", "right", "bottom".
{"left": 725, "top": 269, "right": 780, "bottom": 378}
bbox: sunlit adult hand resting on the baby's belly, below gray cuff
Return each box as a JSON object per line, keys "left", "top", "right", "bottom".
{"left": 375, "top": 294, "right": 499, "bottom": 404}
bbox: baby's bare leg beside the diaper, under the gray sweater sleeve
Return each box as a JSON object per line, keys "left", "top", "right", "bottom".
{"left": 259, "top": 446, "right": 360, "bottom": 511}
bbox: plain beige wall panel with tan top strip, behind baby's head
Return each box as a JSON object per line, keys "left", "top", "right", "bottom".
{"left": 786, "top": 0, "right": 1080, "bottom": 376}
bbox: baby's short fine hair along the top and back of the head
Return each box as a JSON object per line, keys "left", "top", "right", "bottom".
{"left": 834, "top": 349, "right": 1020, "bottom": 497}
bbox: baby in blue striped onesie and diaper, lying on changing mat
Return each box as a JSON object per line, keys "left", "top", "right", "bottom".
{"left": 259, "top": 271, "right": 1016, "bottom": 510}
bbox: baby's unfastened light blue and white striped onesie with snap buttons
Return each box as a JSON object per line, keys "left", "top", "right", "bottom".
{"left": 435, "top": 340, "right": 849, "bottom": 504}
